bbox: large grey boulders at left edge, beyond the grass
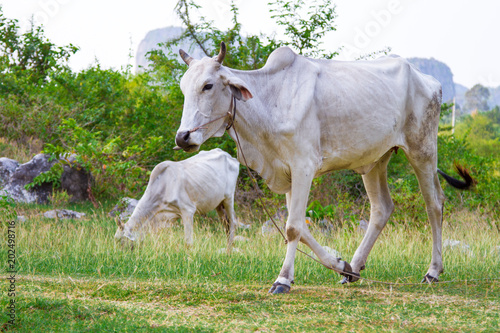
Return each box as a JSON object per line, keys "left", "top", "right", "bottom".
{"left": 0, "top": 154, "right": 91, "bottom": 204}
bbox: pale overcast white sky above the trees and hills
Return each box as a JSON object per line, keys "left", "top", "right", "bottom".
{"left": 0, "top": 0, "right": 500, "bottom": 88}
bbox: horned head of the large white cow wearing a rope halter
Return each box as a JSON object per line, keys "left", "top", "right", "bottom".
{"left": 175, "top": 42, "right": 252, "bottom": 152}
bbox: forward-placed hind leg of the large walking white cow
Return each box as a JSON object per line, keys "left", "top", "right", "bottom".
{"left": 342, "top": 150, "right": 394, "bottom": 283}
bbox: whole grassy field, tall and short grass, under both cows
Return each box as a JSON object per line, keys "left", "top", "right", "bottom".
{"left": 1, "top": 206, "right": 500, "bottom": 332}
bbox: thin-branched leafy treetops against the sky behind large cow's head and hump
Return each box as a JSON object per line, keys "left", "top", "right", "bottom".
{"left": 158, "top": 0, "right": 337, "bottom": 69}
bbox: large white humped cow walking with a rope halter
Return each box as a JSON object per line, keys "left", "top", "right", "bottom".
{"left": 176, "top": 43, "right": 473, "bottom": 293}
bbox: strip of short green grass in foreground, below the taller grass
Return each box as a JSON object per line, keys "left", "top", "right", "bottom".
{"left": 9, "top": 276, "right": 500, "bottom": 332}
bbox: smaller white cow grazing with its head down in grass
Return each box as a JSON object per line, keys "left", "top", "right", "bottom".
{"left": 115, "top": 148, "right": 239, "bottom": 252}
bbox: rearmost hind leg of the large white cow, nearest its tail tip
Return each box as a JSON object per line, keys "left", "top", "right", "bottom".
{"left": 407, "top": 152, "right": 445, "bottom": 282}
